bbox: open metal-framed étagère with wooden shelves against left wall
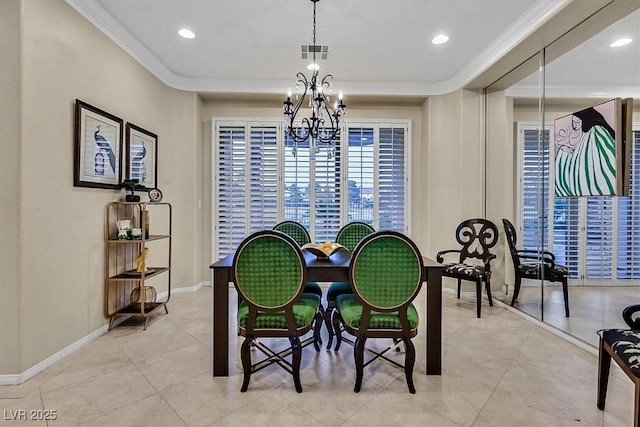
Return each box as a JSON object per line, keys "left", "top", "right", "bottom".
{"left": 105, "top": 202, "right": 172, "bottom": 330}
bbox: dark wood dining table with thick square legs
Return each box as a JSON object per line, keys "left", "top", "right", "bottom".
{"left": 210, "top": 251, "right": 443, "bottom": 377}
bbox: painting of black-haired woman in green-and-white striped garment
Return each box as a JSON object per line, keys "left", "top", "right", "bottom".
{"left": 554, "top": 99, "right": 626, "bottom": 197}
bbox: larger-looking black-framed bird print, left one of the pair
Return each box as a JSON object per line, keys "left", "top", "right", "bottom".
{"left": 73, "top": 99, "right": 123, "bottom": 189}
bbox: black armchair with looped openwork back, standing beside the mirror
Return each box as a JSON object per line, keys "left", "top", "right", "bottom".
{"left": 436, "top": 218, "right": 498, "bottom": 317}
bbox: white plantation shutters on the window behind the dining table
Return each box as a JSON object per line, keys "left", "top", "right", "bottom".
{"left": 212, "top": 120, "right": 408, "bottom": 258}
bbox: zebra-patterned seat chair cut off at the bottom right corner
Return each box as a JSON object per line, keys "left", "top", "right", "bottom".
{"left": 598, "top": 304, "right": 640, "bottom": 427}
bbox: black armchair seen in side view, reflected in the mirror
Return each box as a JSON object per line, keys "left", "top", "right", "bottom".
{"left": 502, "top": 218, "right": 569, "bottom": 317}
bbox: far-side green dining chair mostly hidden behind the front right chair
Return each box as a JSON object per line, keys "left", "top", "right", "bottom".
{"left": 324, "top": 221, "right": 375, "bottom": 350}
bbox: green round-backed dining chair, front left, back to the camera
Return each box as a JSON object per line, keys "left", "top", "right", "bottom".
{"left": 233, "top": 230, "right": 322, "bottom": 393}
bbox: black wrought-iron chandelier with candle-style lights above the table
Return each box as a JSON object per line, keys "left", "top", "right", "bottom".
{"left": 284, "top": 0, "right": 347, "bottom": 157}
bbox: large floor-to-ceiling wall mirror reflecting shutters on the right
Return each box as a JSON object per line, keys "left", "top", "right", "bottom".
{"left": 485, "top": 4, "right": 640, "bottom": 346}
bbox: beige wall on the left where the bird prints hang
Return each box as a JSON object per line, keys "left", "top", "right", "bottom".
{"left": 0, "top": 0, "right": 206, "bottom": 375}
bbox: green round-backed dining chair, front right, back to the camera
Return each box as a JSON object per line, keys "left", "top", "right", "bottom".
{"left": 333, "top": 231, "right": 424, "bottom": 393}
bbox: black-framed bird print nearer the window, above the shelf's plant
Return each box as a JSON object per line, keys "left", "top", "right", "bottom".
{"left": 126, "top": 123, "right": 158, "bottom": 190}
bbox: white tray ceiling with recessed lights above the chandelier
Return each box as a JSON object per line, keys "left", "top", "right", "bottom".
{"left": 67, "top": 0, "right": 640, "bottom": 96}
